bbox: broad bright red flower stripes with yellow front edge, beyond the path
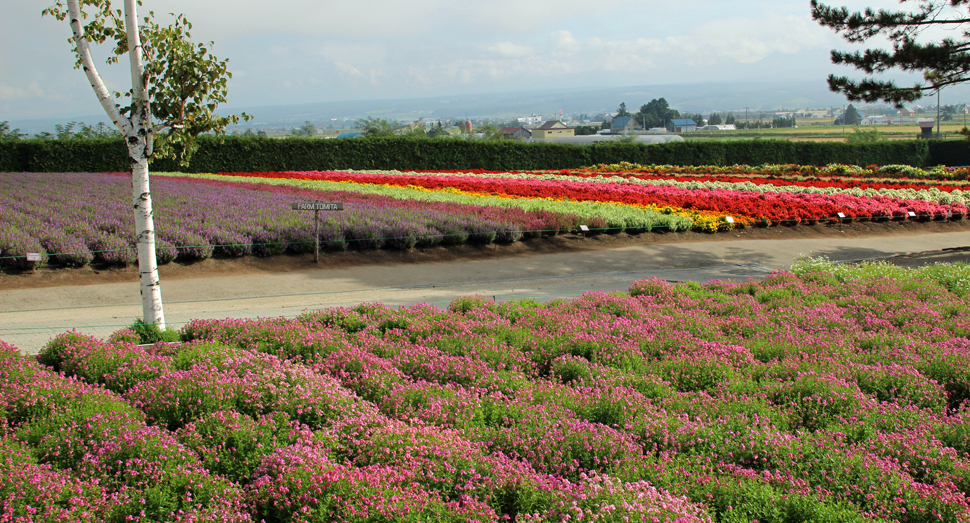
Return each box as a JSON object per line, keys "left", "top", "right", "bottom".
{"left": 197, "top": 166, "right": 968, "bottom": 227}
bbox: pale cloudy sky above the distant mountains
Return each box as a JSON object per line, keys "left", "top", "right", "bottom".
{"left": 0, "top": 0, "right": 960, "bottom": 121}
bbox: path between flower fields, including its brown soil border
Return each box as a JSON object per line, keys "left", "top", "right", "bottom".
{"left": 0, "top": 221, "right": 970, "bottom": 353}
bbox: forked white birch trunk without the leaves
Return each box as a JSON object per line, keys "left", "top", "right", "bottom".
{"left": 67, "top": 0, "right": 165, "bottom": 330}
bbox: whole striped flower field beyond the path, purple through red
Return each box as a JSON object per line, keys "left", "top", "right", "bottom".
{"left": 0, "top": 164, "right": 970, "bottom": 269}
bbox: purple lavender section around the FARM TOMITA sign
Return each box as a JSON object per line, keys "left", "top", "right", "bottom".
{"left": 0, "top": 173, "right": 576, "bottom": 268}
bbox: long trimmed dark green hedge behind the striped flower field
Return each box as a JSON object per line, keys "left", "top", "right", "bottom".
{"left": 0, "top": 137, "right": 970, "bottom": 172}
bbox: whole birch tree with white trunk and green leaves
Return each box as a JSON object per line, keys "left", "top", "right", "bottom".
{"left": 43, "top": 0, "right": 249, "bottom": 330}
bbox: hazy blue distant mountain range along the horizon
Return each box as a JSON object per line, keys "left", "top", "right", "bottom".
{"left": 10, "top": 79, "right": 970, "bottom": 134}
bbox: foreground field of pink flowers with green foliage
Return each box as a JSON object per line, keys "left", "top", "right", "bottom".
{"left": 0, "top": 260, "right": 970, "bottom": 523}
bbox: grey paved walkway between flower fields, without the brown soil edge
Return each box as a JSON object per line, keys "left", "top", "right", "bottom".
{"left": 0, "top": 232, "right": 970, "bottom": 353}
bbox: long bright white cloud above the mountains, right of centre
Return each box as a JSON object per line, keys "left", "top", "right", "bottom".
{"left": 390, "top": 15, "right": 830, "bottom": 92}
